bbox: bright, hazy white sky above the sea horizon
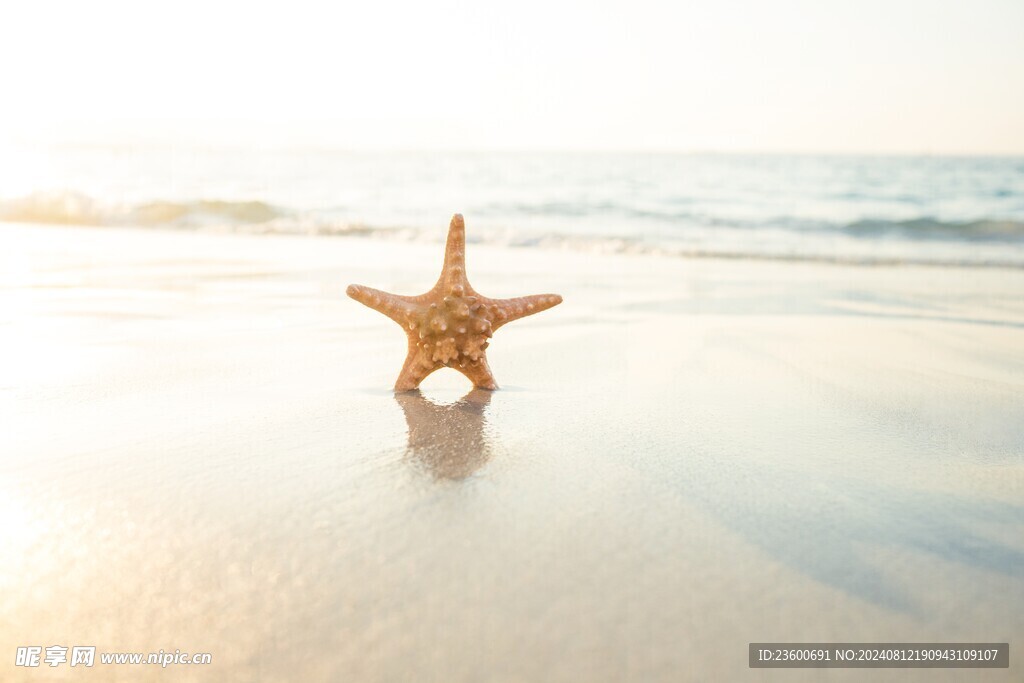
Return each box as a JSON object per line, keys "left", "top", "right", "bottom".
{"left": 6, "top": 0, "right": 1024, "bottom": 154}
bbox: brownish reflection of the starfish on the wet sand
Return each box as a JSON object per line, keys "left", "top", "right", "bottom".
{"left": 394, "top": 389, "right": 493, "bottom": 480}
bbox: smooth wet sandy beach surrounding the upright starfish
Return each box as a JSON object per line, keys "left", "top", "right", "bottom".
{"left": 0, "top": 224, "right": 1024, "bottom": 683}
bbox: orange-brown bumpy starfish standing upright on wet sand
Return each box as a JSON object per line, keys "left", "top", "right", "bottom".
{"left": 346, "top": 213, "right": 562, "bottom": 391}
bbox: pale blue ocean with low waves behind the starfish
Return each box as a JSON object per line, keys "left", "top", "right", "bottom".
{"left": 0, "top": 146, "right": 1024, "bottom": 268}
